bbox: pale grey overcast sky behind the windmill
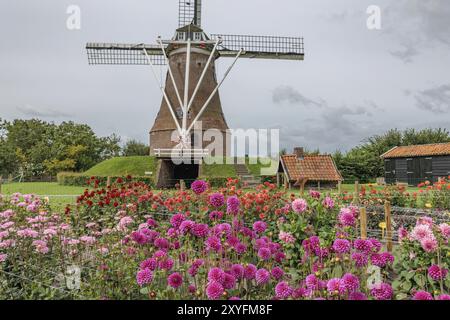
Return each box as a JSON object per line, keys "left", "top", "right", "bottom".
{"left": 0, "top": 0, "right": 450, "bottom": 152}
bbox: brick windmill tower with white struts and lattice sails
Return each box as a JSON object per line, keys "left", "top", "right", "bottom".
{"left": 86, "top": 0, "right": 304, "bottom": 157}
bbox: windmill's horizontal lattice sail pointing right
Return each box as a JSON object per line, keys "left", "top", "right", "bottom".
{"left": 211, "top": 34, "right": 304, "bottom": 60}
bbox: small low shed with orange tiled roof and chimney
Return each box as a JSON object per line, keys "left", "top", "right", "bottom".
{"left": 277, "top": 148, "right": 343, "bottom": 189}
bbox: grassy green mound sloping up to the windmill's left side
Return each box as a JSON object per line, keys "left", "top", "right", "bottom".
{"left": 84, "top": 156, "right": 156, "bottom": 177}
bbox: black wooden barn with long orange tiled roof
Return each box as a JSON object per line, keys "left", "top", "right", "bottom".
{"left": 381, "top": 142, "right": 450, "bottom": 185}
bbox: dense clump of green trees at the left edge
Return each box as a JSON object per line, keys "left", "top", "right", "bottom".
{"left": 0, "top": 119, "right": 120, "bottom": 177}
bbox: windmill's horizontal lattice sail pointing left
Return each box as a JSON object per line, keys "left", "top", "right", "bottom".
{"left": 86, "top": 43, "right": 166, "bottom": 65}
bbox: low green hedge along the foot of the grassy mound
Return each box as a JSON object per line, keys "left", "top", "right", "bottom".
{"left": 57, "top": 172, "right": 155, "bottom": 187}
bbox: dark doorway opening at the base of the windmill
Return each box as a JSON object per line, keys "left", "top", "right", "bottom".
{"left": 158, "top": 160, "right": 199, "bottom": 188}
